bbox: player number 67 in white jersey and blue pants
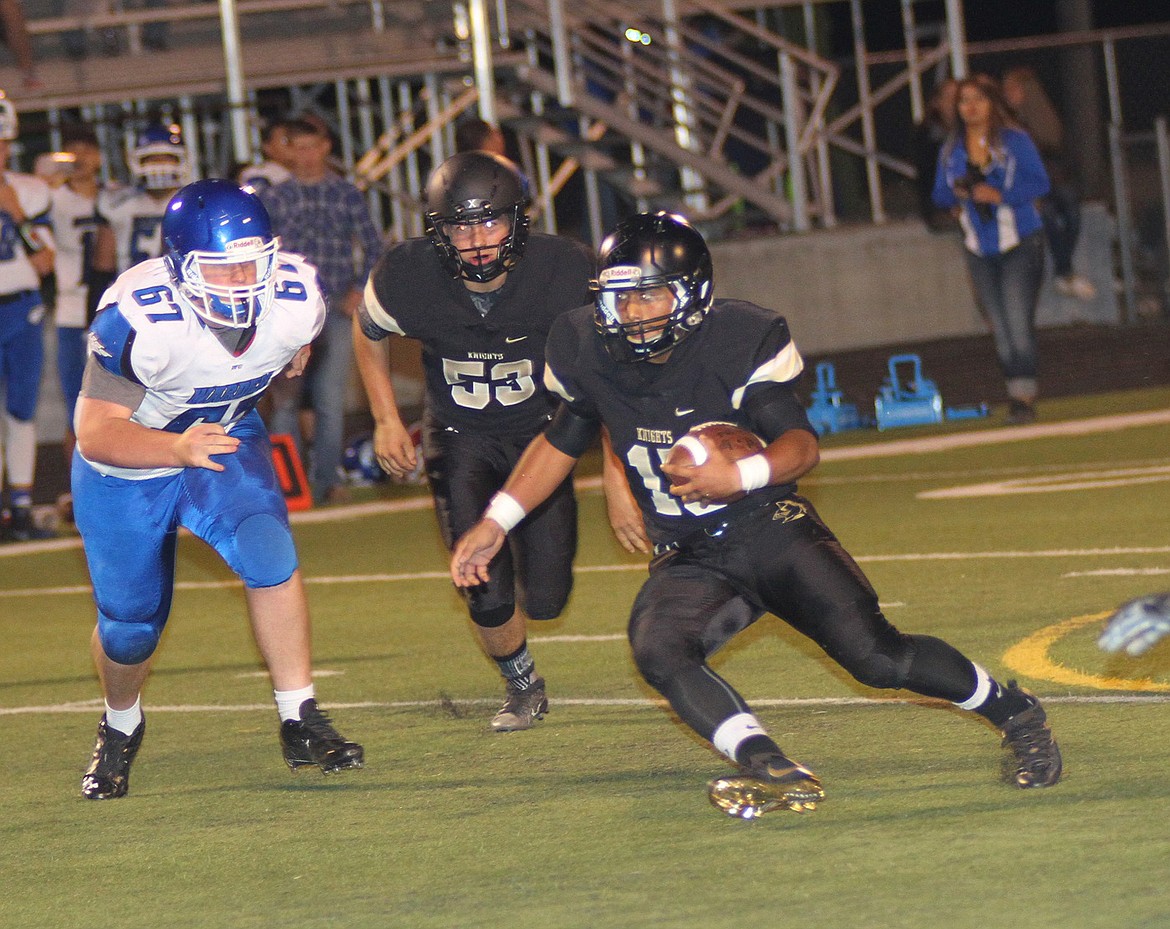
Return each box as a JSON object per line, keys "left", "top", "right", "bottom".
{"left": 73, "top": 179, "right": 363, "bottom": 799}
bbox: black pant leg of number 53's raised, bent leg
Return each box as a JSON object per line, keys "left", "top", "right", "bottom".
{"left": 510, "top": 477, "right": 577, "bottom": 619}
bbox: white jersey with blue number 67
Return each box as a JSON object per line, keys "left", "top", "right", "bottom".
{"left": 89, "top": 252, "right": 325, "bottom": 480}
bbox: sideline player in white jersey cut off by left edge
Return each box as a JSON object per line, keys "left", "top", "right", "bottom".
{"left": 0, "top": 90, "right": 54, "bottom": 542}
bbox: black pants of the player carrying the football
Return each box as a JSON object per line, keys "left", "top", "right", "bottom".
{"left": 629, "top": 495, "right": 976, "bottom": 739}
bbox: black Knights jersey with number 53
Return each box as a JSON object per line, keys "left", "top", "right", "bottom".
{"left": 365, "top": 235, "right": 591, "bottom": 434}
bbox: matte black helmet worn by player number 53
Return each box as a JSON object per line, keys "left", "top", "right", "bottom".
{"left": 426, "top": 151, "right": 529, "bottom": 284}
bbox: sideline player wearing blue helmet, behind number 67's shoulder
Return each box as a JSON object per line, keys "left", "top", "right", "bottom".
{"left": 96, "top": 125, "right": 191, "bottom": 271}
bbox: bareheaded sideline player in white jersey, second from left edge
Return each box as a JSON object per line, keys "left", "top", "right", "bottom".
{"left": 50, "top": 125, "right": 113, "bottom": 461}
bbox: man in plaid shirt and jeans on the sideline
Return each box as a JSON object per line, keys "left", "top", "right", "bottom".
{"left": 264, "top": 119, "right": 381, "bottom": 503}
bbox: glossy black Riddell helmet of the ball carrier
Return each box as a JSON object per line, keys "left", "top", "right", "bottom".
{"left": 592, "top": 212, "right": 714, "bottom": 362}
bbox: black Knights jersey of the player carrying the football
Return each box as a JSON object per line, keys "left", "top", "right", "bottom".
{"left": 545, "top": 300, "right": 813, "bottom": 543}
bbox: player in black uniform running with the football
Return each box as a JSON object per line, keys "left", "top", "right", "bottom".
{"left": 452, "top": 213, "right": 1061, "bottom": 819}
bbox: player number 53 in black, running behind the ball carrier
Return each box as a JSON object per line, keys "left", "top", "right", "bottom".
{"left": 353, "top": 151, "right": 628, "bottom": 731}
